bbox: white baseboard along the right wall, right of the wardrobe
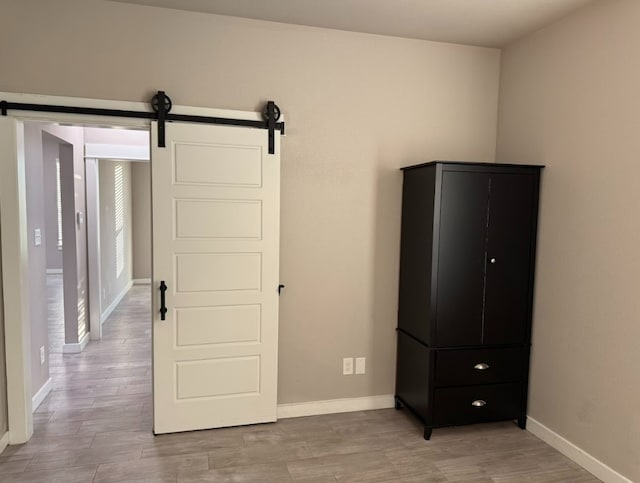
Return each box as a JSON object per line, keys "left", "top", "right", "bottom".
{"left": 527, "top": 417, "right": 632, "bottom": 483}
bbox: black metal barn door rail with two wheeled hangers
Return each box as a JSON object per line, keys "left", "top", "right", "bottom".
{"left": 0, "top": 91, "right": 284, "bottom": 154}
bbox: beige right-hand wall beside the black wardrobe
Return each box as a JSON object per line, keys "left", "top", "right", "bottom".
{"left": 497, "top": 0, "right": 640, "bottom": 481}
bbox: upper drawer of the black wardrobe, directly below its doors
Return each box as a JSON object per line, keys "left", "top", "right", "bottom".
{"left": 435, "top": 349, "right": 527, "bottom": 387}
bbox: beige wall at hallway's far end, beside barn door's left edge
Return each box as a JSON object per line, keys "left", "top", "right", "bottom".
{"left": 131, "top": 163, "right": 151, "bottom": 280}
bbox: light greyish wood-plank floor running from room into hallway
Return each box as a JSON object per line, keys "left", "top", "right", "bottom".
{"left": 0, "top": 286, "right": 598, "bottom": 483}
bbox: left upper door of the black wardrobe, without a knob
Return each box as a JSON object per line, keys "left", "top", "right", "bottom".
{"left": 436, "top": 171, "right": 489, "bottom": 347}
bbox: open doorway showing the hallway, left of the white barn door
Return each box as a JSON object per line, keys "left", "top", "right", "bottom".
{"left": 24, "top": 122, "right": 152, "bottom": 434}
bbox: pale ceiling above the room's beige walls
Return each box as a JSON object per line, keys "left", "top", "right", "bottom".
{"left": 111, "top": 0, "right": 594, "bottom": 47}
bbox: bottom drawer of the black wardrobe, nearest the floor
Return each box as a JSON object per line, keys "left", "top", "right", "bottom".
{"left": 433, "top": 384, "right": 522, "bottom": 426}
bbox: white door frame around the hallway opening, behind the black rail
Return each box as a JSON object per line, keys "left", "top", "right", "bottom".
{"left": 0, "top": 92, "right": 268, "bottom": 444}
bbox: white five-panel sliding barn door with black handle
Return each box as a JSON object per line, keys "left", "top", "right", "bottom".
{"left": 151, "top": 122, "right": 280, "bottom": 434}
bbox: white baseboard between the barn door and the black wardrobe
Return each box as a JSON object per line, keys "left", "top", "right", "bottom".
{"left": 277, "top": 394, "right": 394, "bottom": 419}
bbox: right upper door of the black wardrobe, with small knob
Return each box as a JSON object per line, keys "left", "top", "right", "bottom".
{"left": 482, "top": 174, "right": 537, "bottom": 344}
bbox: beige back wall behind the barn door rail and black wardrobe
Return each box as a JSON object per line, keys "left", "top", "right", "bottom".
{"left": 0, "top": 0, "right": 500, "bottom": 403}
